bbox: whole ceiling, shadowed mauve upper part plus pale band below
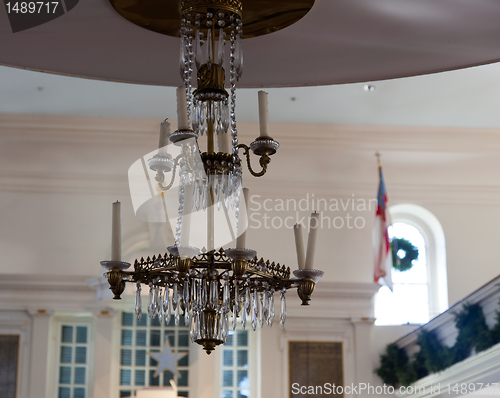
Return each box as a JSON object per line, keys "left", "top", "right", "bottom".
{"left": 0, "top": 0, "right": 500, "bottom": 127}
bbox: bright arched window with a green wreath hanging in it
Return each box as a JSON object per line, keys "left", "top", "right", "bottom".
{"left": 375, "top": 204, "right": 448, "bottom": 325}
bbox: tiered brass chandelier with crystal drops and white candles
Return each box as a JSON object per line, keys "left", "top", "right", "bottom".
{"left": 101, "top": 0, "right": 323, "bottom": 354}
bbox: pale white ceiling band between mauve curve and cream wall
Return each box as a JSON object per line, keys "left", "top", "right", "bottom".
{"left": 0, "top": 61, "right": 500, "bottom": 127}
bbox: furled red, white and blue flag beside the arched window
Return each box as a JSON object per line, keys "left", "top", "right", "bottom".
{"left": 373, "top": 163, "right": 392, "bottom": 290}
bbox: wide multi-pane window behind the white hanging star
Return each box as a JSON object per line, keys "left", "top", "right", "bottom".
{"left": 119, "top": 312, "right": 190, "bottom": 397}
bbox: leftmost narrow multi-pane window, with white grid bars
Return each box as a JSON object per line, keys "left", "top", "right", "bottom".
{"left": 57, "top": 324, "right": 89, "bottom": 398}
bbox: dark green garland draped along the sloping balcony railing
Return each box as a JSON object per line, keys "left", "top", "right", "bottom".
{"left": 375, "top": 304, "right": 500, "bottom": 386}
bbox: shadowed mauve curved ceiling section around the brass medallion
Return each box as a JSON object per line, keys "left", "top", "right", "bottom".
{"left": 0, "top": 0, "right": 500, "bottom": 87}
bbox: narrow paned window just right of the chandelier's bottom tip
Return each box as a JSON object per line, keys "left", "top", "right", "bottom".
{"left": 221, "top": 330, "right": 250, "bottom": 398}
